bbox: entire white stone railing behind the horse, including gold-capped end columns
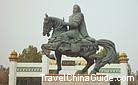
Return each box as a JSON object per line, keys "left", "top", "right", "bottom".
{"left": 9, "top": 51, "right": 128, "bottom": 85}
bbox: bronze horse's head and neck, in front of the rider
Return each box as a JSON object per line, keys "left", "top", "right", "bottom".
{"left": 43, "top": 14, "right": 67, "bottom": 37}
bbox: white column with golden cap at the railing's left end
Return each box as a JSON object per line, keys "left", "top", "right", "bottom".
{"left": 9, "top": 50, "right": 18, "bottom": 85}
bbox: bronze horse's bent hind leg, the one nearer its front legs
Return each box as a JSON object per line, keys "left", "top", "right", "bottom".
{"left": 75, "top": 57, "right": 94, "bottom": 74}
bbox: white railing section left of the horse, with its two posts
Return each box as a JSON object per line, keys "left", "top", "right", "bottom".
{"left": 9, "top": 55, "right": 49, "bottom": 85}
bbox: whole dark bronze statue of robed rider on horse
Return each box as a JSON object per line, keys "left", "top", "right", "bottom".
{"left": 41, "top": 5, "right": 117, "bottom": 74}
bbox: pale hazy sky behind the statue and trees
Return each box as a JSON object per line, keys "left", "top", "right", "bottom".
{"left": 0, "top": 0, "right": 138, "bottom": 71}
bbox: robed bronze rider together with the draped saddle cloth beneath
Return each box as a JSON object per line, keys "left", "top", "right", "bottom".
{"left": 42, "top": 4, "right": 96, "bottom": 52}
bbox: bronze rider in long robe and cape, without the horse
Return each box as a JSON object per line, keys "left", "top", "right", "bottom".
{"left": 61, "top": 4, "right": 95, "bottom": 42}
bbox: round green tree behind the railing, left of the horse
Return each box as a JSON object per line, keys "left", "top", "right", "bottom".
{"left": 18, "top": 45, "right": 42, "bottom": 62}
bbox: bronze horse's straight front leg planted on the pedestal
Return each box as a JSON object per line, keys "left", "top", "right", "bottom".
{"left": 55, "top": 51, "right": 62, "bottom": 74}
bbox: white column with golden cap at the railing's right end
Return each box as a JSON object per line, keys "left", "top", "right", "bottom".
{"left": 119, "top": 52, "right": 129, "bottom": 85}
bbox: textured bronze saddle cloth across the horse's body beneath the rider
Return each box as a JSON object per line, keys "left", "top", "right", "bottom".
{"left": 48, "top": 38, "right": 95, "bottom": 52}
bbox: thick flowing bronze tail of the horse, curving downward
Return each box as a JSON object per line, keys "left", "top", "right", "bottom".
{"left": 97, "top": 39, "right": 117, "bottom": 66}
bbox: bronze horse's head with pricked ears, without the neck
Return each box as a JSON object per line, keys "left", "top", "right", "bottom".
{"left": 43, "top": 14, "right": 53, "bottom": 37}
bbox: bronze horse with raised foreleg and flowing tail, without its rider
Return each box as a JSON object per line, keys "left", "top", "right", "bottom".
{"left": 41, "top": 15, "right": 117, "bottom": 74}
